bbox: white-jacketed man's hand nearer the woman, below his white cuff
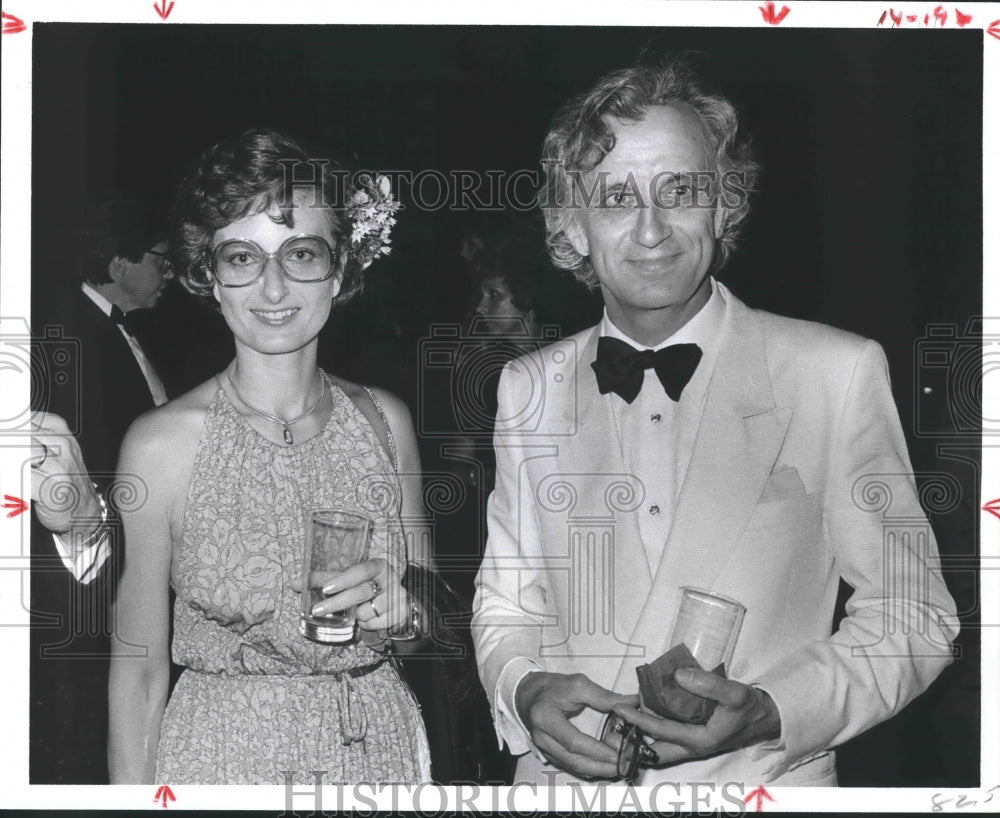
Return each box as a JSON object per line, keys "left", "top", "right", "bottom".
{"left": 514, "top": 671, "right": 627, "bottom": 778}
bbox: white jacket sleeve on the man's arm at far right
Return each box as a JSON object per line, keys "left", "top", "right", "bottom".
{"left": 755, "top": 341, "right": 958, "bottom": 774}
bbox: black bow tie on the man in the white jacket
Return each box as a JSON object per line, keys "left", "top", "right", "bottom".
{"left": 591, "top": 336, "right": 701, "bottom": 403}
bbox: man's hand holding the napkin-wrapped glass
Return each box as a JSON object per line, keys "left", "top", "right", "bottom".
{"left": 614, "top": 668, "right": 781, "bottom": 764}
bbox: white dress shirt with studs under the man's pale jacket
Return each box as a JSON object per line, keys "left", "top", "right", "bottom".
{"left": 494, "top": 279, "right": 726, "bottom": 758}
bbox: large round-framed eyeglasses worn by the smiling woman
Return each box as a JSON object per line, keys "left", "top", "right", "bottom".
{"left": 211, "top": 236, "right": 333, "bottom": 287}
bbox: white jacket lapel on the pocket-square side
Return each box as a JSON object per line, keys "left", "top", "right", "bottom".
{"left": 604, "top": 295, "right": 792, "bottom": 689}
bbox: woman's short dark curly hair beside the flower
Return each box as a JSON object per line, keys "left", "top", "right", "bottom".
{"left": 170, "top": 128, "right": 364, "bottom": 303}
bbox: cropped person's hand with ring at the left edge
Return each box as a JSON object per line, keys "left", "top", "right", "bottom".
{"left": 31, "top": 412, "right": 101, "bottom": 538}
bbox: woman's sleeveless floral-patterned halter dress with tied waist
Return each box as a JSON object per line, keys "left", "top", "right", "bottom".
{"left": 156, "top": 379, "right": 430, "bottom": 786}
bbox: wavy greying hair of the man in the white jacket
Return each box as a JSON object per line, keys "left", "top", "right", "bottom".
{"left": 539, "top": 57, "right": 760, "bottom": 288}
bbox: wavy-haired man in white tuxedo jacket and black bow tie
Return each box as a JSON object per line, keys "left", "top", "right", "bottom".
{"left": 473, "top": 57, "right": 957, "bottom": 787}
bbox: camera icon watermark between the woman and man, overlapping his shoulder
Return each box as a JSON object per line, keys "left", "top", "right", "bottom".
{"left": 417, "top": 319, "right": 577, "bottom": 439}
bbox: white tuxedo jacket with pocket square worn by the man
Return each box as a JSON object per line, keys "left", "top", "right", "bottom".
{"left": 473, "top": 291, "right": 957, "bottom": 787}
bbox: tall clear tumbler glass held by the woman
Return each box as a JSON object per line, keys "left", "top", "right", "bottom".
{"left": 299, "top": 509, "right": 372, "bottom": 645}
